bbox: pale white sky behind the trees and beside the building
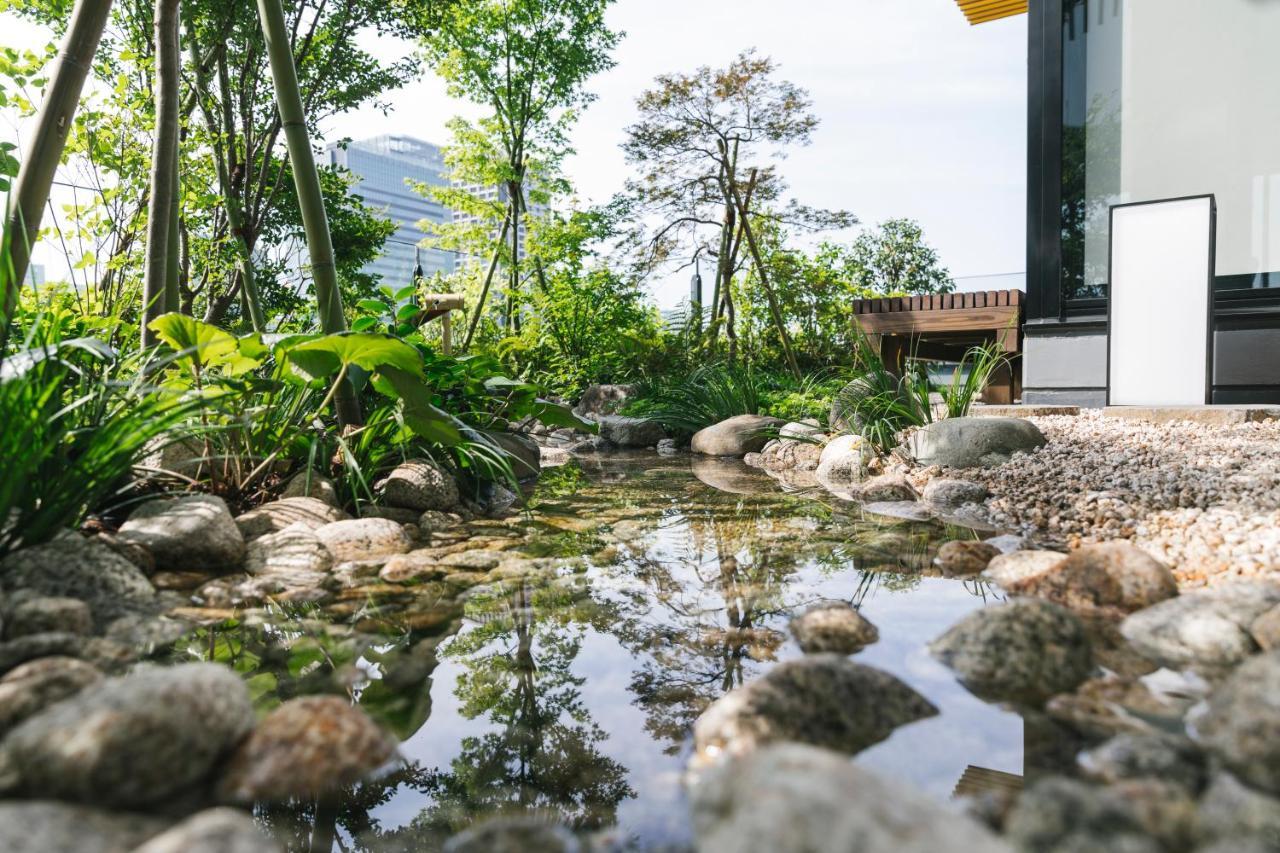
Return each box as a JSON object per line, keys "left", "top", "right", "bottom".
{"left": 0, "top": 0, "right": 1027, "bottom": 306}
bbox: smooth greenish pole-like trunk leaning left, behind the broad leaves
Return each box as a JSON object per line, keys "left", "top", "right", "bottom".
{"left": 257, "top": 0, "right": 361, "bottom": 425}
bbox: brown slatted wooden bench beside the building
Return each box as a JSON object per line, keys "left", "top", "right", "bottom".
{"left": 854, "top": 291, "right": 1023, "bottom": 405}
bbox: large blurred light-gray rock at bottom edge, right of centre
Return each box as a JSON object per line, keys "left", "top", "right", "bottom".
{"left": 690, "top": 743, "right": 1010, "bottom": 853}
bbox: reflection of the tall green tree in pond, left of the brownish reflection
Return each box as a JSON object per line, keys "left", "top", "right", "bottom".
{"left": 389, "top": 583, "right": 635, "bottom": 840}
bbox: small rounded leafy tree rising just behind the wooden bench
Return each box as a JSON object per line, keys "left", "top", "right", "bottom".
{"left": 849, "top": 219, "right": 955, "bottom": 295}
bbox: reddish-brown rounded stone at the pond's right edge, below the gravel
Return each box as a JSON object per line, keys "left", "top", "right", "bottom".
{"left": 1001, "top": 542, "right": 1178, "bottom": 616}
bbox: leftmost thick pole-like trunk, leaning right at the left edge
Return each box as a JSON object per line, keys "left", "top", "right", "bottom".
{"left": 0, "top": 0, "right": 111, "bottom": 346}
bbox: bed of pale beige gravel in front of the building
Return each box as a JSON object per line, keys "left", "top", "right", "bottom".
{"left": 921, "top": 412, "right": 1280, "bottom": 587}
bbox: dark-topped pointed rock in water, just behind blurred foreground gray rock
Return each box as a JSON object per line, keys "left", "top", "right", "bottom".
{"left": 694, "top": 654, "right": 938, "bottom": 763}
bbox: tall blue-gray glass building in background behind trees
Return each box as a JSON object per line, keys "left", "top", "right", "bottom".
{"left": 328, "top": 136, "right": 456, "bottom": 287}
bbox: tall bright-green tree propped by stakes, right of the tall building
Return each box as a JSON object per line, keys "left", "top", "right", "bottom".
{"left": 424, "top": 0, "right": 620, "bottom": 346}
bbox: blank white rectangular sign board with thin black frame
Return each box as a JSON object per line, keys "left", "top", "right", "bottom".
{"left": 1107, "top": 196, "right": 1215, "bottom": 406}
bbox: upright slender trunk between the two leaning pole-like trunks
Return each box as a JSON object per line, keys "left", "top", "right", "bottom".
{"left": 142, "top": 0, "right": 179, "bottom": 347}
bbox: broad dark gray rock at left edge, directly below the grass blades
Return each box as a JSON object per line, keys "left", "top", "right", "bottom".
{"left": 0, "top": 534, "right": 155, "bottom": 626}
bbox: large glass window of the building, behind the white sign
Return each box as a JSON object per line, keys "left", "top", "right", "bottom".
{"left": 1061, "top": 0, "right": 1280, "bottom": 300}
